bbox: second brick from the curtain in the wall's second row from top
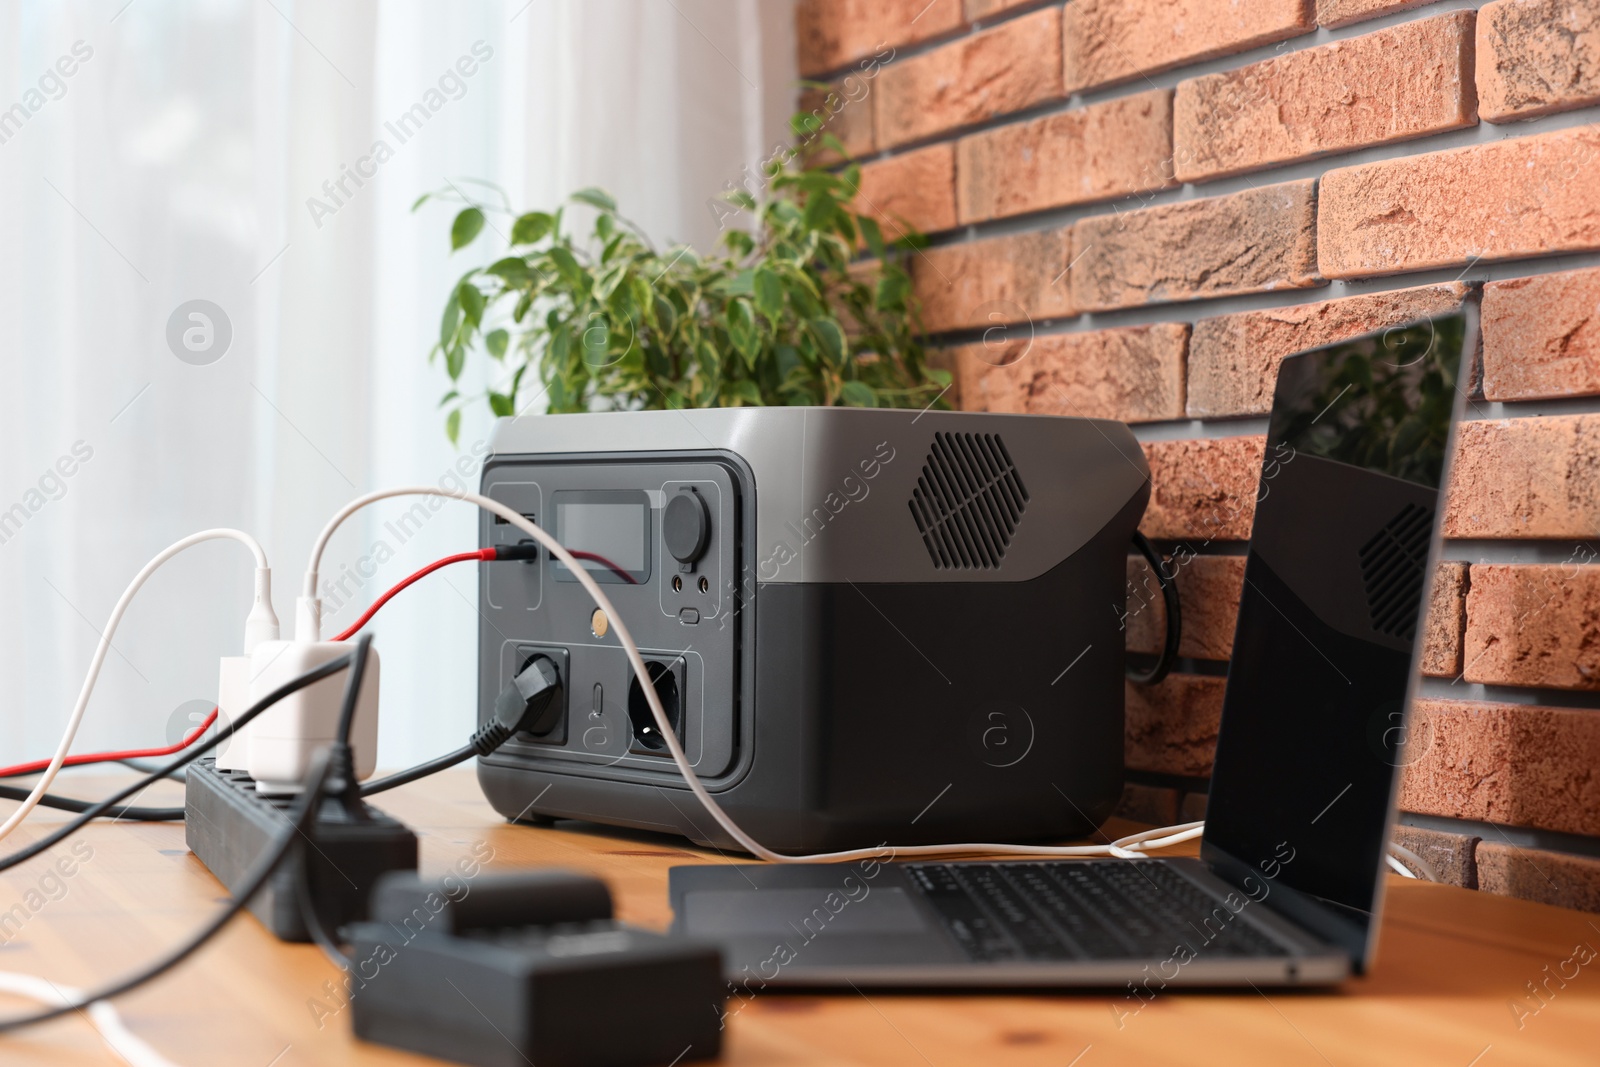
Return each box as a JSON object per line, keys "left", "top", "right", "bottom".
{"left": 877, "top": 8, "right": 1061, "bottom": 147}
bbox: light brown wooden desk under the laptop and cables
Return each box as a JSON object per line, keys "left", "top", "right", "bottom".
{"left": 0, "top": 773, "right": 1600, "bottom": 1067}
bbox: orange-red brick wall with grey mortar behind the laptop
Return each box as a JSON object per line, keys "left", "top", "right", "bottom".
{"left": 798, "top": 0, "right": 1600, "bottom": 909}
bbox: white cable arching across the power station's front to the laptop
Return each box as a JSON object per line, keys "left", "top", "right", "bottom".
{"left": 305, "top": 485, "right": 1205, "bottom": 864}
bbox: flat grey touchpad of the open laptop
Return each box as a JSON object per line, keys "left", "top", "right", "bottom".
{"left": 682, "top": 886, "right": 928, "bottom": 939}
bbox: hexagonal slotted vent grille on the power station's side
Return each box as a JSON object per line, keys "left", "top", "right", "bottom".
{"left": 910, "top": 434, "right": 1027, "bottom": 571}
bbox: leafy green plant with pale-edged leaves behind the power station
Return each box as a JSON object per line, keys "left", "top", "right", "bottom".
{"left": 413, "top": 126, "right": 950, "bottom": 442}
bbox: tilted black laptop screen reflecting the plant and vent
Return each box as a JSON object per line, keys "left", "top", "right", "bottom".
{"left": 1202, "top": 314, "right": 1469, "bottom": 966}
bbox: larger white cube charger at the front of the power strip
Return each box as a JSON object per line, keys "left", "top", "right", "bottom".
{"left": 241, "top": 641, "right": 379, "bottom": 793}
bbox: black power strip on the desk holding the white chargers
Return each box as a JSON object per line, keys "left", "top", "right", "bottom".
{"left": 184, "top": 760, "right": 416, "bottom": 941}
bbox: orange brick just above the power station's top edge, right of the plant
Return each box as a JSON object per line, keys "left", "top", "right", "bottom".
{"left": 957, "top": 323, "right": 1189, "bottom": 422}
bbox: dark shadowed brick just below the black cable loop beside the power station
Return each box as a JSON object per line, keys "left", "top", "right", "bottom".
{"left": 1123, "top": 673, "right": 1226, "bottom": 777}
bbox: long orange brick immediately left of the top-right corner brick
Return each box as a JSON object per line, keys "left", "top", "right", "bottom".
{"left": 1173, "top": 11, "right": 1478, "bottom": 182}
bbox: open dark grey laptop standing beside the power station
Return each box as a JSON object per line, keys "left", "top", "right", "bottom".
{"left": 670, "top": 307, "right": 1477, "bottom": 990}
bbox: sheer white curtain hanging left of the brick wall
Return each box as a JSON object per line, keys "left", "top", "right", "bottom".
{"left": 0, "top": 0, "right": 795, "bottom": 766}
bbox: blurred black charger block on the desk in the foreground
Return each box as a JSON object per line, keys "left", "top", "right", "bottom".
{"left": 349, "top": 870, "right": 726, "bottom": 1067}
